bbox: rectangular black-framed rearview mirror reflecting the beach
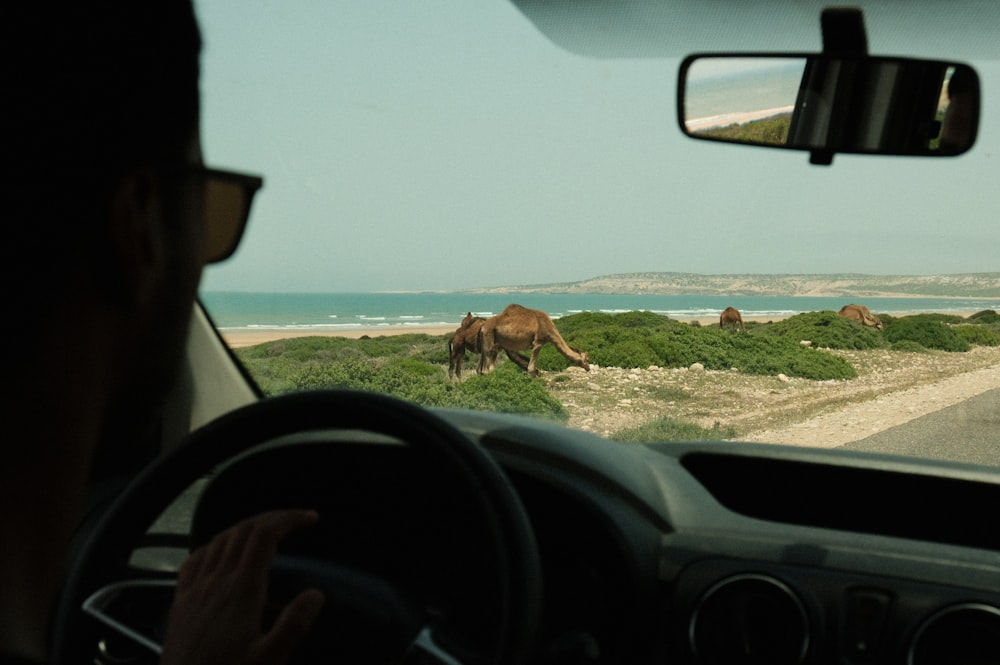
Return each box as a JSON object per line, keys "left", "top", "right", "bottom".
{"left": 677, "top": 54, "right": 979, "bottom": 156}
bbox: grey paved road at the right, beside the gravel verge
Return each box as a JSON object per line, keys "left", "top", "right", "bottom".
{"left": 843, "top": 389, "right": 1000, "bottom": 466}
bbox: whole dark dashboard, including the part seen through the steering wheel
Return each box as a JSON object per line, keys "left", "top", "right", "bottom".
{"left": 90, "top": 402, "right": 1000, "bottom": 665}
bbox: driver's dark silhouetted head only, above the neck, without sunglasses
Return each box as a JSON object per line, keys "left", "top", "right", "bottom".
{"left": 0, "top": 0, "right": 202, "bottom": 400}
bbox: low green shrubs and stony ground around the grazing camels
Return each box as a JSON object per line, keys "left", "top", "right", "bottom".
{"left": 235, "top": 310, "right": 1000, "bottom": 441}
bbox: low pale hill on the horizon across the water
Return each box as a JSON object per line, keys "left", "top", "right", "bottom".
{"left": 460, "top": 272, "right": 1000, "bottom": 298}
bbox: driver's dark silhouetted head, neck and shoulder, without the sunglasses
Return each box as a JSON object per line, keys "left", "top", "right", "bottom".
{"left": 0, "top": 0, "right": 204, "bottom": 659}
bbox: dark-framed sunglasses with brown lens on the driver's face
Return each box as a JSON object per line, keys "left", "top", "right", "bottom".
{"left": 190, "top": 166, "right": 264, "bottom": 263}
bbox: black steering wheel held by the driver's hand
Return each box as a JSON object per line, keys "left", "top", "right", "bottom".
{"left": 52, "top": 391, "right": 541, "bottom": 665}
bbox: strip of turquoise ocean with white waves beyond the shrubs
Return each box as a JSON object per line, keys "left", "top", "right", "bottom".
{"left": 200, "top": 292, "right": 1000, "bottom": 332}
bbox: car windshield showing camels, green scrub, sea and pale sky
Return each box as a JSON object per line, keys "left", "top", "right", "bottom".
{"left": 198, "top": 0, "right": 1000, "bottom": 465}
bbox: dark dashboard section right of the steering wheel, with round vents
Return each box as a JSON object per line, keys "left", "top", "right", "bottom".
{"left": 445, "top": 412, "right": 1000, "bottom": 665}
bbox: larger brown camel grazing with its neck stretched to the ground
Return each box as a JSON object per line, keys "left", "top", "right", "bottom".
{"left": 479, "top": 304, "right": 590, "bottom": 376}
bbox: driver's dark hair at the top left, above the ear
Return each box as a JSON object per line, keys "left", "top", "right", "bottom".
{"left": 0, "top": 0, "right": 201, "bottom": 306}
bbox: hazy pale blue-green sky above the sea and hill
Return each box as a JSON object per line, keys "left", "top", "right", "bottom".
{"left": 196, "top": 0, "right": 1000, "bottom": 291}
